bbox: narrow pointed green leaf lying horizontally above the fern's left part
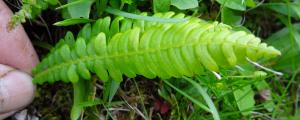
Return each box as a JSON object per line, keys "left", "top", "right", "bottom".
{"left": 53, "top": 18, "right": 93, "bottom": 26}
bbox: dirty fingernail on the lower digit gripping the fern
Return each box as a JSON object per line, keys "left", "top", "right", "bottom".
{"left": 0, "top": 64, "right": 34, "bottom": 114}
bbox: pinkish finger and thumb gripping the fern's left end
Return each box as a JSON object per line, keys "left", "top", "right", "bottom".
{"left": 0, "top": 0, "right": 38, "bottom": 119}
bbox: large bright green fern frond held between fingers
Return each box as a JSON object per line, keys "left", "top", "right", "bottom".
{"left": 33, "top": 12, "right": 281, "bottom": 84}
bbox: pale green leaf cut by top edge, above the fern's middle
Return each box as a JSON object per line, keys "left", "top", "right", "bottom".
{"left": 171, "top": 0, "right": 198, "bottom": 10}
